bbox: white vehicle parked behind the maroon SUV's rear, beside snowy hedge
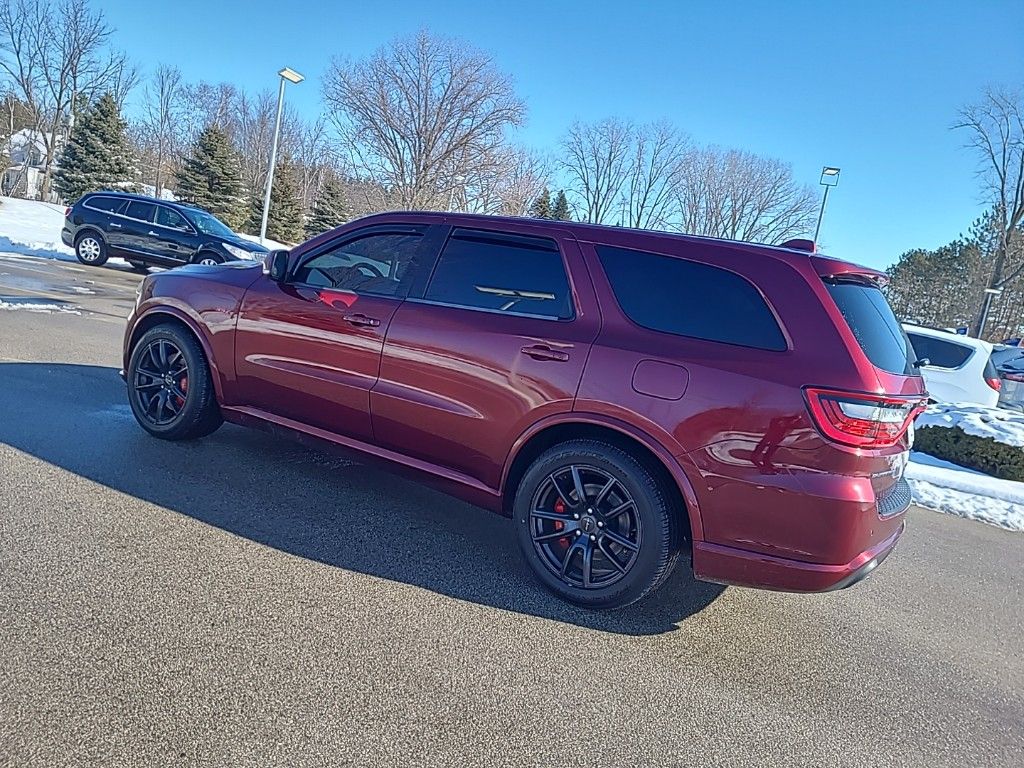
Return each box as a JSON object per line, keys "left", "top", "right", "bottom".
{"left": 903, "top": 324, "right": 1000, "bottom": 408}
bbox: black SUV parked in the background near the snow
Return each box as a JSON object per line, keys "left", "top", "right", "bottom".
{"left": 60, "top": 191, "right": 267, "bottom": 269}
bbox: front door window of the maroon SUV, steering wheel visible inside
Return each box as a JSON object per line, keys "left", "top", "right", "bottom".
{"left": 293, "top": 231, "right": 423, "bottom": 296}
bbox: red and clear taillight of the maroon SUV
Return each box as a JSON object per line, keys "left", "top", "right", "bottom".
{"left": 804, "top": 387, "right": 926, "bottom": 447}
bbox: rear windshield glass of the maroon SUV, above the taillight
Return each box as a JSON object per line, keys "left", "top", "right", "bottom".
{"left": 825, "top": 280, "right": 916, "bottom": 376}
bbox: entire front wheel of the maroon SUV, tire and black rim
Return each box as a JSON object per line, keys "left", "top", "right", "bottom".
{"left": 126, "top": 324, "right": 223, "bottom": 440}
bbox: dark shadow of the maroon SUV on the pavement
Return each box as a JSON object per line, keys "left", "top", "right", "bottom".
{"left": 0, "top": 362, "right": 724, "bottom": 635}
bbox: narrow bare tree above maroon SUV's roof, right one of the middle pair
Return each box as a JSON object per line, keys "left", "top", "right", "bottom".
{"left": 622, "top": 121, "right": 686, "bottom": 229}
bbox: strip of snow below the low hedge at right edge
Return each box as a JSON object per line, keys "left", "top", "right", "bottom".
{"left": 905, "top": 452, "right": 1024, "bottom": 531}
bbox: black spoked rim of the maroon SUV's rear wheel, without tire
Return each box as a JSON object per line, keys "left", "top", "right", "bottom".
{"left": 529, "top": 464, "right": 642, "bottom": 589}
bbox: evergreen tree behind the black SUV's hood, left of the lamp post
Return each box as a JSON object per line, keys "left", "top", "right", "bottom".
{"left": 174, "top": 125, "right": 246, "bottom": 229}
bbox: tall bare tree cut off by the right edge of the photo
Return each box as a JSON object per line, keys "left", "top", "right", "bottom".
{"left": 953, "top": 88, "right": 1024, "bottom": 336}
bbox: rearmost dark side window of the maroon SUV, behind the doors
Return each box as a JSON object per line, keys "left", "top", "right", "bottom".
{"left": 597, "top": 246, "right": 786, "bottom": 351}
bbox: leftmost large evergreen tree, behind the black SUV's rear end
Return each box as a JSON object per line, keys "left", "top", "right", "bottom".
{"left": 54, "top": 93, "right": 136, "bottom": 203}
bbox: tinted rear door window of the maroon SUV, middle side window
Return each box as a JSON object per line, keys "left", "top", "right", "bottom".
{"left": 424, "top": 229, "right": 572, "bottom": 319}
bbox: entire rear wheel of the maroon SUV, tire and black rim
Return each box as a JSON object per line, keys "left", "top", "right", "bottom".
{"left": 513, "top": 439, "right": 679, "bottom": 608}
